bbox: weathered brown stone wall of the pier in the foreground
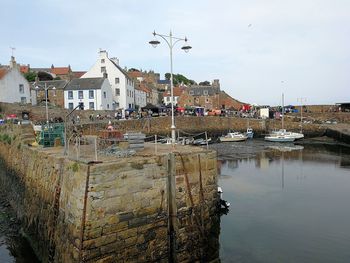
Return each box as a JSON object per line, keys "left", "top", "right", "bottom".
{"left": 0, "top": 125, "right": 218, "bottom": 262}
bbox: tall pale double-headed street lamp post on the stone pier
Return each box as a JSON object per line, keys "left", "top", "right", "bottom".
{"left": 149, "top": 31, "right": 192, "bottom": 145}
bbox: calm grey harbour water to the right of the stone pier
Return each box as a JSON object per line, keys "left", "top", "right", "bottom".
{"left": 219, "top": 145, "right": 350, "bottom": 263}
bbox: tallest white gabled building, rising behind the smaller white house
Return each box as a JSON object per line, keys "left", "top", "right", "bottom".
{"left": 81, "top": 50, "right": 135, "bottom": 110}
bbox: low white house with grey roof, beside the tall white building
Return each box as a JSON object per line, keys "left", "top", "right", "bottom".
{"left": 64, "top": 78, "right": 113, "bottom": 110}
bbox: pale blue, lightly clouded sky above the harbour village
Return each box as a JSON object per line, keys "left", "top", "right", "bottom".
{"left": 0, "top": 0, "right": 350, "bottom": 105}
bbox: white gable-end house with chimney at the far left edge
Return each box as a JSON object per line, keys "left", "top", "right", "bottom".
{"left": 0, "top": 56, "right": 31, "bottom": 104}
